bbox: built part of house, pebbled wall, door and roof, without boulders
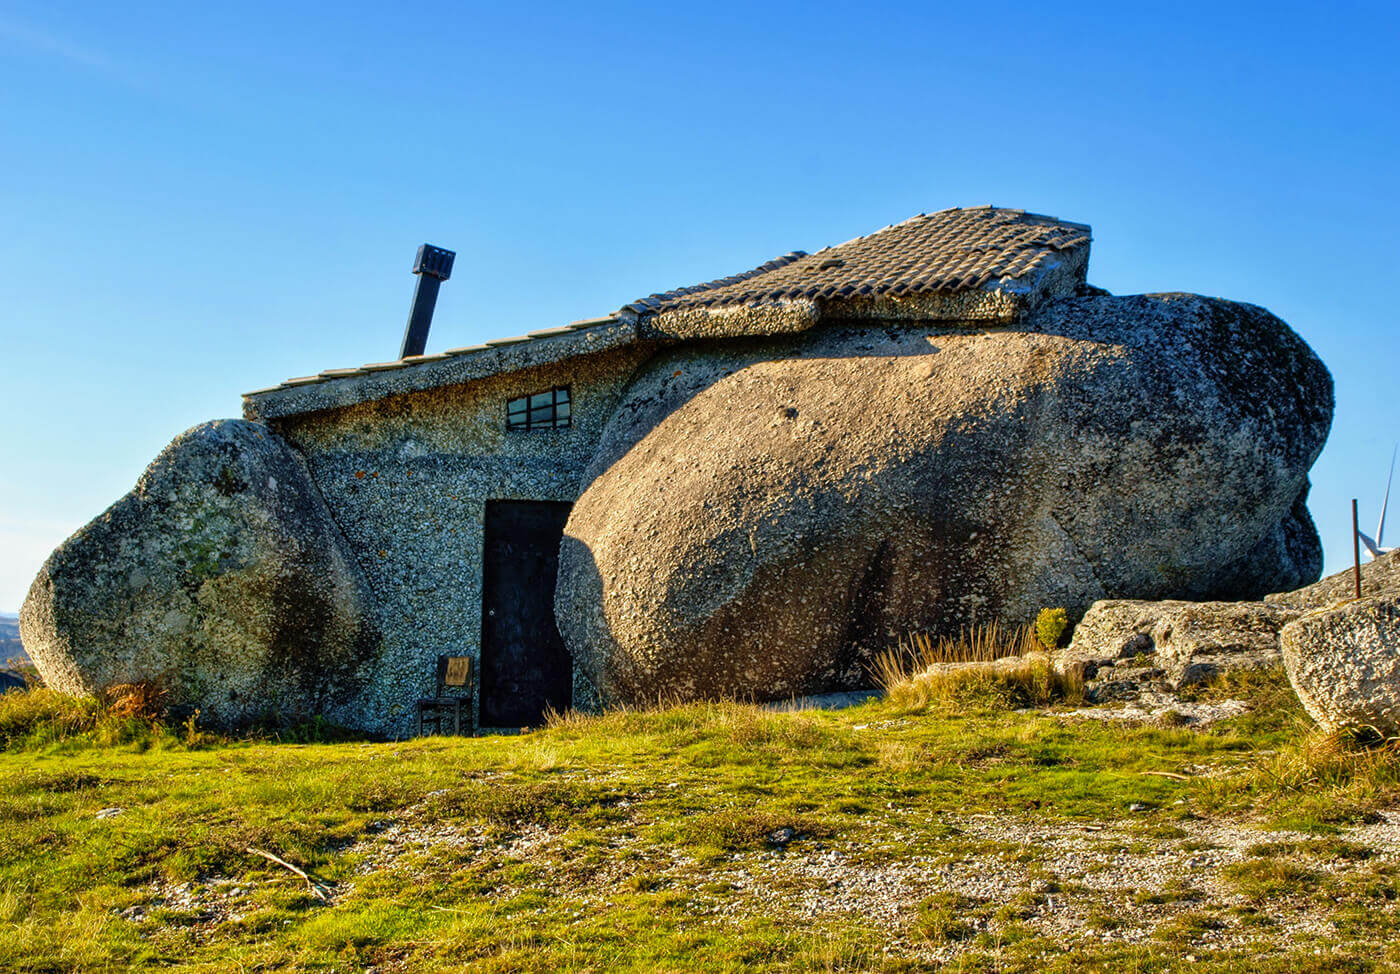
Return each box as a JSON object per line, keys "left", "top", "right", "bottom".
{"left": 244, "top": 207, "right": 1089, "bottom": 726}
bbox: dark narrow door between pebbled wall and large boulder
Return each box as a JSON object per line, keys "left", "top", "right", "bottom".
{"left": 482, "top": 501, "right": 574, "bottom": 728}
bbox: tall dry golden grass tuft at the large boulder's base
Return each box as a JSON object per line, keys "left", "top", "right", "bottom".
{"left": 872, "top": 621, "right": 1084, "bottom": 710}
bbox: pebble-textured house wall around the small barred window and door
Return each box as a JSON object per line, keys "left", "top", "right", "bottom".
{"left": 273, "top": 343, "right": 651, "bottom": 735}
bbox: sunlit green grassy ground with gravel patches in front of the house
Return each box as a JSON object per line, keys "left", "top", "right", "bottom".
{"left": 0, "top": 675, "right": 1400, "bottom": 974}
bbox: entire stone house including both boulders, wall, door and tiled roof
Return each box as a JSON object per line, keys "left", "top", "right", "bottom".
{"left": 21, "top": 207, "right": 1333, "bottom": 735}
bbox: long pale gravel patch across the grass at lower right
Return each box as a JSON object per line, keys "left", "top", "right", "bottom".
{"left": 324, "top": 813, "right": 1400, "bottom": 960}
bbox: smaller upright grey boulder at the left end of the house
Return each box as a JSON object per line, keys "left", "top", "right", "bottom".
{"left": 20, "top": 420, "right": 378, "bottom": 725}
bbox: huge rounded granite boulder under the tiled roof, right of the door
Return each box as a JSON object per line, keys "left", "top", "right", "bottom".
{"left": 556, "top": 294, "right": 1333, "bottom": 703}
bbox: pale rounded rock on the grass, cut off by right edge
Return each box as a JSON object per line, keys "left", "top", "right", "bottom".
{"left": 1280, "top": 593, "right": 1400, "bottom": 737}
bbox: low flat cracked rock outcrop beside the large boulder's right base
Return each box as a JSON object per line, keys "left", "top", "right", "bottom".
{"left": 1056, "top": 599, "right": 1299, "bottom": 700}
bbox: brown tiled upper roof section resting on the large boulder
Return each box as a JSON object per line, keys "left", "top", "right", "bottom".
{"left": 622, "top": 206, "right": 1089, "bottom": 315}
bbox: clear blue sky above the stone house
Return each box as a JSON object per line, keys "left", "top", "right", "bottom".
{"left": 0, "top": 0, "right": 1400, "bottom": 612}
